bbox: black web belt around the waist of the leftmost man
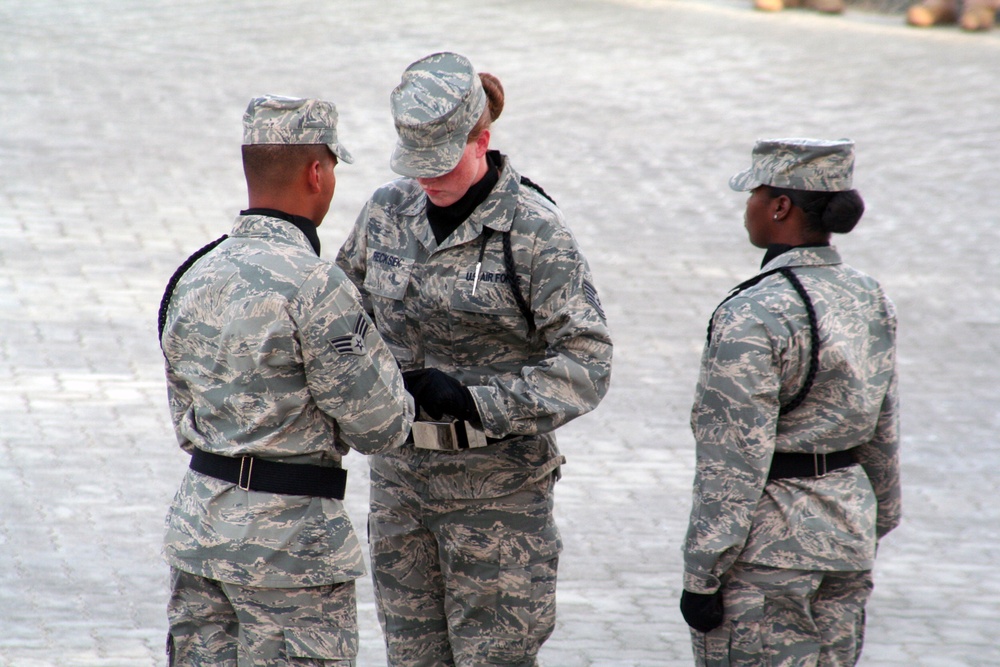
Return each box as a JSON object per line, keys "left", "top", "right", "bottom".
{"left": 191, "top": 449, "right": 347, "bottom": 500}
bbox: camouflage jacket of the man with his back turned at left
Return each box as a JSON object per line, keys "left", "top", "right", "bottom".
{"left": 161, "top": 215, "right": 413, "bottom": 588}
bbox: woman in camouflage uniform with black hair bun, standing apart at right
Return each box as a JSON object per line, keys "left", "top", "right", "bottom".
{"left": 681, "top": 139, "right": 900, "bottom": 666}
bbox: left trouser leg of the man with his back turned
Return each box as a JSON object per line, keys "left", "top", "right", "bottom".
{"left": 167, "top": 568, "right": 239, "bottom": 667}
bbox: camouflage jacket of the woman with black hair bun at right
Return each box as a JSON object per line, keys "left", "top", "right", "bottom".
{"left": 684, "top": 247, "right": 900, "bottom": 593}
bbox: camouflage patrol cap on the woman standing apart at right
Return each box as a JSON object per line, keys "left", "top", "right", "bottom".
{"left": 729, "top": 139, "right": 854, "bottom": 192}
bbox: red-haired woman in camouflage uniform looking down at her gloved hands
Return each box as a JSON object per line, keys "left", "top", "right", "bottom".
{"left": 337, "top": 53, "right": 612, "bottom": 667}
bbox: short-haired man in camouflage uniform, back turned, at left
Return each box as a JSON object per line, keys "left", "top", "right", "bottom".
{"left": 160, "top": 96, "right": 413, "bottom": 667}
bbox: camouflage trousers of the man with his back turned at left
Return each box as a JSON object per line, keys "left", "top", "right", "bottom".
{"left": 167, "top": 568, "right": 358, "bottom": 667}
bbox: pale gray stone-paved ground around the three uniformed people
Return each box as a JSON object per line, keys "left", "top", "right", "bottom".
{"left": 0, "top": 0, "right": 1000, "bottom": 667}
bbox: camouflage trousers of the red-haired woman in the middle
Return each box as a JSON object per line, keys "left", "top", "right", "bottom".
{"left": 369, "top": 469, "right": 561, "bottom": 667}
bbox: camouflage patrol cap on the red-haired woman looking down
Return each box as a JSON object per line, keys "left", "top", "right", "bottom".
{"left": 389, "top": 52, "right": 486, "bottom": 178}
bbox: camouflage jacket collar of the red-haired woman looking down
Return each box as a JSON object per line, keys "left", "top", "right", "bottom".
{"left": 396, "top": 153, "right": 522, "bottom": 251}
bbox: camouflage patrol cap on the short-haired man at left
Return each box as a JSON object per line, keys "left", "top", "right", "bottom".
{"left": 243, "top": 95, "right": 354, "bottom": 164}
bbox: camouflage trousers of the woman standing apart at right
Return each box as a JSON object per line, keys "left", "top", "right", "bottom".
{"left": 691, "top": 563, "right": 873, "bottom": 667}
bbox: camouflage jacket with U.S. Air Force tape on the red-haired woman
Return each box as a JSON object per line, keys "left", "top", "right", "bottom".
{"left": 337, "top": 158, "right": 612, "bottom": 498}
